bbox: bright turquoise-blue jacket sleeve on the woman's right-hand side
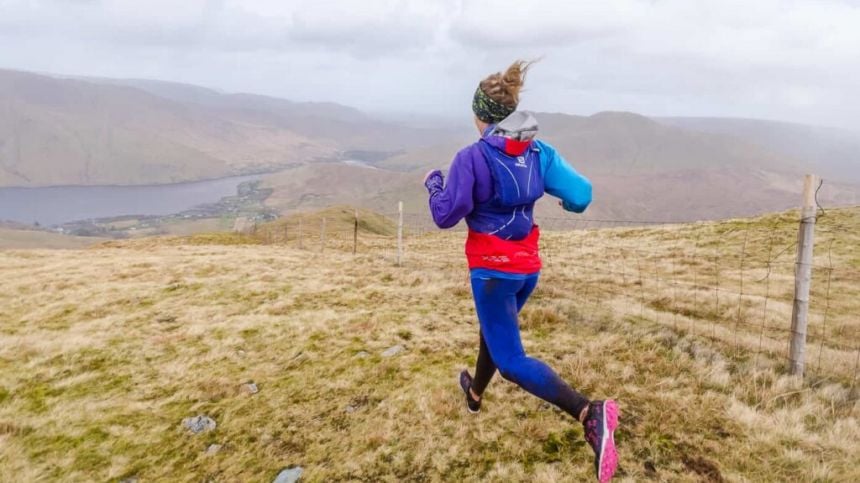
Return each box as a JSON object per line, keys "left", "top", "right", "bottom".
{"left": 535, "top": 141, "right": 591, "bottom": 213}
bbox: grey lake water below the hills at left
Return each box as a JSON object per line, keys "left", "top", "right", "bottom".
{"left": 0, "top": 175, "right": 261, "bottom": 226}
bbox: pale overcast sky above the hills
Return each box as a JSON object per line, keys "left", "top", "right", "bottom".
{"left": 0, "top": 0, "right": 860, "bottom": 130}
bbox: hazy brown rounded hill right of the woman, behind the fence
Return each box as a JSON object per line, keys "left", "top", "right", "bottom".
{"left": 538, "top": 112, "right": 860, "bottom": 221}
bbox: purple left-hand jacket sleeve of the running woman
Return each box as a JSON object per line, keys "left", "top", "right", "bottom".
{"left": 424, "top": 149, "right": 475, "bottom": 228}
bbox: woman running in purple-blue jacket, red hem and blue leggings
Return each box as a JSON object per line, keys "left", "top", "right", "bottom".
{"left": 424, "top": 61, "right": 618, "bottom": 482}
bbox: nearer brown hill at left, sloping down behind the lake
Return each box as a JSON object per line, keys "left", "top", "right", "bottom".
{"left": 0, "top": 71, "right": 336, "bottom": 186}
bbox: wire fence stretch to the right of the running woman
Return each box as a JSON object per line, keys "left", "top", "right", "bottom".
{"left": 543, "top": 220, "right": 860, "bottom": 386}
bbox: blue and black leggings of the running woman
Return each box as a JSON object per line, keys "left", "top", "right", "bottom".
{"left": 472, "top": 275, "right": 588, "bottom": 418}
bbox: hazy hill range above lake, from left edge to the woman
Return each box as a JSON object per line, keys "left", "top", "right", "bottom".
{"left": 0, "top": 70, "right": 450, "bottom": 187}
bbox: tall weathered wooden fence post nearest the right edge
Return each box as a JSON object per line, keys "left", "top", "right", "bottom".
{"left": 788, "top": 174, "right": 818, "bottom": 378}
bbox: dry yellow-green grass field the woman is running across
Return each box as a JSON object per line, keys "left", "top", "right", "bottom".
{"left": 0, "top": 209, "right": 860, "bottom": 482}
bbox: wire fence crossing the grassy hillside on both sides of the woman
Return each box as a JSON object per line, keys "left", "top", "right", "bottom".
{"left": 244, "top": 204, "right": 860, "bottom": 389}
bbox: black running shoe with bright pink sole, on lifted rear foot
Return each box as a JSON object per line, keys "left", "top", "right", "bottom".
{"left": 582, "top": 399, "right": 618, "bottom": 483}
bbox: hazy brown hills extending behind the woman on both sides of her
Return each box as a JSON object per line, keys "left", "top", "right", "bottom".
{"left": 267, "top": 112, "right": 860, "bottom": 221}
